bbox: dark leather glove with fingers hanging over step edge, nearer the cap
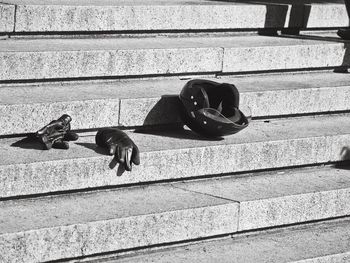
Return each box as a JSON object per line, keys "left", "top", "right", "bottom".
{"left": 95, "top": 128, "right": 140, "bottom": 171}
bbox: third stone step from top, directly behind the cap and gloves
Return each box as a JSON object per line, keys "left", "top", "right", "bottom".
{"left": 0, "top": 72, "right": 350, "bottom": 135}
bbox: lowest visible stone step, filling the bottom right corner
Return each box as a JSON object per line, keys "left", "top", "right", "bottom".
{"left": 87, "top": 219, "right": 350, "bottom": 263}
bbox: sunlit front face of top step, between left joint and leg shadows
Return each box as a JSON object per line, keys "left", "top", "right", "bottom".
{"left": 11, "top": 1, "right": 265, "bottom": 32}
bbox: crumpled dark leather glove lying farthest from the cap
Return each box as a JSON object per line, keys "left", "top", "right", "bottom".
{"left": 35, "top": 114, "right": 79, "bottom": 150}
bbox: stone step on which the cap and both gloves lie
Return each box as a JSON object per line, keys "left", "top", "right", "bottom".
{"left": 0, "top": 114, "right": 350, "bottom": 198}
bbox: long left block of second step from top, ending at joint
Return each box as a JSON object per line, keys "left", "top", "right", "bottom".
{"left": 0, "top": 38, "right": 222, "bottom": 80}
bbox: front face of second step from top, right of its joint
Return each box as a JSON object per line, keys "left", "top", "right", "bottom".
{"left": 223, "top": 41, "right": 350, "bottom": 72}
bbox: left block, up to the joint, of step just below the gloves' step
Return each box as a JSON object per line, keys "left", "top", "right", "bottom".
{"left": 0, "top": 185, "right": 238, "bottom": 263}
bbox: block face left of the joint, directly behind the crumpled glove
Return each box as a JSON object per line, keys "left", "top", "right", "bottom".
{"left": 0, "top": 99, "right": 119, "bottom": 134}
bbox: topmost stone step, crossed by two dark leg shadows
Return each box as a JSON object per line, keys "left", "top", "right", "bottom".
{"left": 0, "top": 0, "right": 348, "bottom": 32}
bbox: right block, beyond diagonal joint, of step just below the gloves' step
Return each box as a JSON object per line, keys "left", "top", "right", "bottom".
{"left": 174, "top": 167, "right": 350, "bottom": 231}
